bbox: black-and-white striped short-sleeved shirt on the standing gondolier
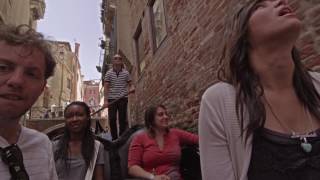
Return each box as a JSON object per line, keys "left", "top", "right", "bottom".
{"left": 104, "top": 69, "right": 131, "bottom": 99}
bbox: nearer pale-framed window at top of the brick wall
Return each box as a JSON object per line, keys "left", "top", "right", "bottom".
{"left": 150, "top": 0, "right": 167, "bottom": 49}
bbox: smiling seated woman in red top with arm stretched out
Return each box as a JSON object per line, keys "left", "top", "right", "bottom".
{"left": 128, "top": 105, "right": 199, "bottom": 180}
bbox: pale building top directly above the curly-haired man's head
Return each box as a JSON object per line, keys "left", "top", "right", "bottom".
{"left": 0, "top": 0, "right": 46, "bottom": 29}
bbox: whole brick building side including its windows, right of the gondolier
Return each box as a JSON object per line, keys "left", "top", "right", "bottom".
{"left": 100, "top": 0, "right": 320, "bottom": 130}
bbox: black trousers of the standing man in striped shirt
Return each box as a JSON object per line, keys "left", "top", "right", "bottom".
{"left": 108, "top": 98, "right": 128, "bottom": 140}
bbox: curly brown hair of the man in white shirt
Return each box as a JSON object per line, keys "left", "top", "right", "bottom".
{"left": 0, "top": 24, "right": 56, "bottom": 79}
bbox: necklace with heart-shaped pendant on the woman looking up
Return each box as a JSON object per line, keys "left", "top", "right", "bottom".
{"left": 263, "top": 96, "right": 317, "bottom": 153}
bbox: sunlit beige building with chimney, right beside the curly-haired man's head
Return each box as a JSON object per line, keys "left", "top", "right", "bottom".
{"left": 30, "top": 41, "right": 83, "bottom": 118}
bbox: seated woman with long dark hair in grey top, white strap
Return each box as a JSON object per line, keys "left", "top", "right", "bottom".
{"left": 54, "top": 101, "right": 104, "bottom": 180}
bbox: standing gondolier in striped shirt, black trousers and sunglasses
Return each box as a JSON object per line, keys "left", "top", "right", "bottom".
{"left": 103, "top": 54, "right": 134, "bottom": 140}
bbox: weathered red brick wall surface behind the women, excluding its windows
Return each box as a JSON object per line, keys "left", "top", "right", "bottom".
{"left": 124, "top": 0, "right": 320, "bottom": 130}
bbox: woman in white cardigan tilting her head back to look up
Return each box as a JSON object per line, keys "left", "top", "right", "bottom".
{"left": 199, "top": 0, "right": 320, "bottom": 180}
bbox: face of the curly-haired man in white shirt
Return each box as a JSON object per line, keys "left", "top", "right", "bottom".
{"left": 0, "top": 41, "right": 46, "bottom": 121}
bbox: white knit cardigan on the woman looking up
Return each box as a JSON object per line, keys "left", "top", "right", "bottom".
{"left": 199, "top": 72, "right": 320, "bottom": 180}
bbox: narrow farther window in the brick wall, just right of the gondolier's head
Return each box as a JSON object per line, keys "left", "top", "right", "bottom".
{"left": 134, "top": 22, "right": 146, "bottom": 74}
